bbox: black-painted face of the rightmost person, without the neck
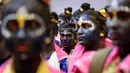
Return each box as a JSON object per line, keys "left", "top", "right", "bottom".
{"left": 107, "top": 6, "right": 130, "bottom": 45}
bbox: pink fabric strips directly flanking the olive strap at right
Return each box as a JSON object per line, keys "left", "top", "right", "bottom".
{"left": 72, "top": 47, "right": 118, "bottom": 73}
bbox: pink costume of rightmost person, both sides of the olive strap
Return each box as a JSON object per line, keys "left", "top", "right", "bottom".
{"left": 71, "top": 46, "right": 130, "bottom": 73}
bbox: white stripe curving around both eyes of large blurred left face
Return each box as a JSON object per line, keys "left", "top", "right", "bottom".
{"left": 1, "top": 6, "right": 46, "bottom": 38}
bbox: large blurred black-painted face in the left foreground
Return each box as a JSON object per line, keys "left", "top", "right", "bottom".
{"left": 1, "top": 0, "right": 52, "bottom": 60}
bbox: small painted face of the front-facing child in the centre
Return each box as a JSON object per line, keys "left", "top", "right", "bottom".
{"left": 59, "top": 23, "right": 75, "bottom": 54}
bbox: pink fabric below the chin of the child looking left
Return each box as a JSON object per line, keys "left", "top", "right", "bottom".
{"left": 68, "top": 44, "right": 85, "bottom": 73}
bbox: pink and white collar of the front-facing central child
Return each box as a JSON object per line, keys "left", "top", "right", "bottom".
{"left": 48, "top": 36, "right": 68, "bottom": 70}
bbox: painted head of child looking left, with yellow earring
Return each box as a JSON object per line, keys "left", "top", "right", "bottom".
{"left": 76, "top": 11, "right": 112, "bottom": 50}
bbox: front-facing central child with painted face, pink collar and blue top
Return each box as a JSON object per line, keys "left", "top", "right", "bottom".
{"left": 50, "top": 23, "right": 75, "bottom": 73}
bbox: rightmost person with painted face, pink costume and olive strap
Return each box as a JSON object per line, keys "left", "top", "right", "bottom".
{"left": 69, "top": 0, "right": 130, "bottom": 73}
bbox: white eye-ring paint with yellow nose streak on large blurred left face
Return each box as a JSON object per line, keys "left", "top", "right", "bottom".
{"left": 1, "top": 6, "right": 46, "bottom": 38}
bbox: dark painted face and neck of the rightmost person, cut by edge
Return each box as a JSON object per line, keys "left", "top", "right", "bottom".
{"left": 107, "top": 3, "right": 130, "bottom": 59}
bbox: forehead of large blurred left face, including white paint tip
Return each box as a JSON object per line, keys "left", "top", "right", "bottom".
{"left": 2, "top": 0, "right": 50, "bottom": 24}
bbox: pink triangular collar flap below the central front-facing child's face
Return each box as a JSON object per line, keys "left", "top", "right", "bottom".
{"left": 54, "top": 43, "right": 68, "bottom": 61}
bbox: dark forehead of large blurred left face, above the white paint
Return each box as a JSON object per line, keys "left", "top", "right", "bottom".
{"left": 4, "top": 0, "right": 48, "bottom": 15}
